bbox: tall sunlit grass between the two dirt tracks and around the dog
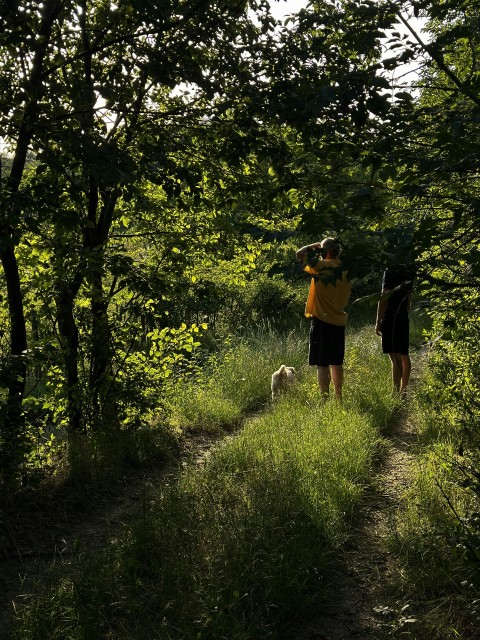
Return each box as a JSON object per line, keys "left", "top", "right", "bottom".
{"left": 16, "top": 328, "right": 397, "bottom": 640}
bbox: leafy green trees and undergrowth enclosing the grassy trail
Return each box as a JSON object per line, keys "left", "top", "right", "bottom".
{"left": 0, "top": 0, "right": 480, "bottom": 636}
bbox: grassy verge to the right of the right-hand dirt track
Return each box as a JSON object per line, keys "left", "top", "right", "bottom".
{"left": 390, "top": 344, "right": 480, "bottom": 640}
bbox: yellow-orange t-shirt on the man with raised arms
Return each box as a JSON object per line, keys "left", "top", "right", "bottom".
{"left": 305, "top": 259, "right": 352, "bottom": 326}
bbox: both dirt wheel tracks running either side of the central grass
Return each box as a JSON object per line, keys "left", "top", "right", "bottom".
{"left": 0, "top": 396, "right": 416, "bottom": 640}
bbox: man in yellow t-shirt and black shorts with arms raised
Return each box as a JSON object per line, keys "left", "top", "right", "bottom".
{"left": 296, "top": 238, "right": 351, "bottom": 400}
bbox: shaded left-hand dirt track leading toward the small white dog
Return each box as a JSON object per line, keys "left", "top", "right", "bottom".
{"left": 0, "top": 436, "right": 218, "bottom": 640}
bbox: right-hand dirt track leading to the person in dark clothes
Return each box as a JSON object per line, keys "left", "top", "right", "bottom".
{"left": 285, "top": 407, "right": 417, "bottom": 640}
